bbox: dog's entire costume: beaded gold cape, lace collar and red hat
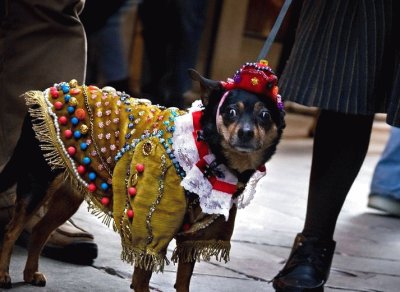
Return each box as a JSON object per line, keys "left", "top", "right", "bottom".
{"left": 25, "top": 62, "right": 282, "bottom": 271}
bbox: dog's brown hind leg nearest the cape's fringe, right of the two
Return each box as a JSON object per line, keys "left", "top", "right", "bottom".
{"left": 24, "top": 179, "right": 83, "bottom": 286}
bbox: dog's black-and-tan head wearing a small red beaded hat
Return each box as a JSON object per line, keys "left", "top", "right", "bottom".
{"left": 189, "top": 62, "right": 285, "bottom": 173}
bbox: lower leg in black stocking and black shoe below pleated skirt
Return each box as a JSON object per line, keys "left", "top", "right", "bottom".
{"left": 273, "top": 110, "right": 373, "bottom": 291}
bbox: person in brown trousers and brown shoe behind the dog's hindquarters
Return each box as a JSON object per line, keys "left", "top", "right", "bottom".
{"left": 0, "top": 0, "right": 97, "bottom": 264}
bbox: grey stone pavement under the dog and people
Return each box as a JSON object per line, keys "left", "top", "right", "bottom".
{"left": 6, "top": 113, "right": 400, "bottom": 292}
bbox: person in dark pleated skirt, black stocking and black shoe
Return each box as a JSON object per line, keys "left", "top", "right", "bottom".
{"left": 273, "top": 0, "right": 400, "bottom": 291}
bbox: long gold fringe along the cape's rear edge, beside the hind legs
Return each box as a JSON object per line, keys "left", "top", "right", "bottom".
{"left": 24, "top": 91, "right": 115, "bottom": 228}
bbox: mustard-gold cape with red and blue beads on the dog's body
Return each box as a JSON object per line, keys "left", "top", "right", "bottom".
{"left": 25, "top": 80, "right": 187, "bottom": 271}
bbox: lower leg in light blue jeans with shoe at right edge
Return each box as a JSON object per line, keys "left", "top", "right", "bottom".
{"left": 368, "top": 127, "right": 400, "bottom": 216}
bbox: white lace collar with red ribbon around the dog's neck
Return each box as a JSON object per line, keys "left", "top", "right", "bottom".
{"left": 172, "top": 102, "right": 266, "bottom": 220}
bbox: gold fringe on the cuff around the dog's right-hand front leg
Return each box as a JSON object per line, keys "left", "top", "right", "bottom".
{"left": 171, "top": 240, "right": 231, "bottom": 263}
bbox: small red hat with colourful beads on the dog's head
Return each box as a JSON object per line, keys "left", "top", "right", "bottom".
{"left": 221, "top": 60, "right": 283, "bottom": 110}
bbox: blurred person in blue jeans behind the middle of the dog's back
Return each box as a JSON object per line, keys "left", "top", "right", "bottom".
{"left": 81, "top": 0, "right": 140, "bottom": 94}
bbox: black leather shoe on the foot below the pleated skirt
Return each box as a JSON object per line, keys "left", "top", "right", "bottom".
{"left": 272, "top": 233, "right": 336, "bottom": 292}
